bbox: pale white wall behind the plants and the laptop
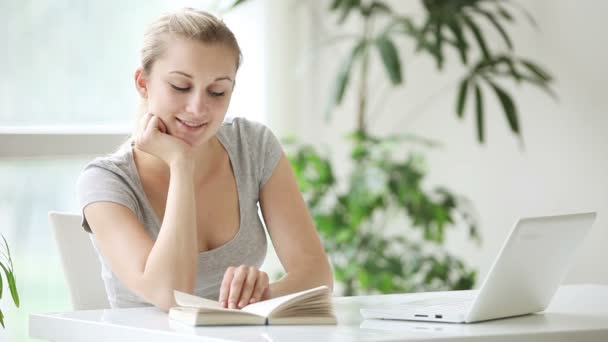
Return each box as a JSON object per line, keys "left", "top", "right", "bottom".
{"left": 270, "top": 0, "right": 608, "bottom": 284}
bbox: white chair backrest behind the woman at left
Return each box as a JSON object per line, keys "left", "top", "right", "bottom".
{"left": 49, "top": 211, "right": 110, "bottom": 310}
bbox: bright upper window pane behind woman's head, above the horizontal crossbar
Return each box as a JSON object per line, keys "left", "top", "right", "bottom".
{"left": 0, "top": 0, "right": 266, "bottom": 130}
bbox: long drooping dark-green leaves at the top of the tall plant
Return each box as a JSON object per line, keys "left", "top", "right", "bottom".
{"left": 328, "top": 0, "right": 555, "bottom": 143}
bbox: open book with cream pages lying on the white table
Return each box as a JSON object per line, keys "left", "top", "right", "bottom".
{"left": 169, "top": 286, "right": 336, "bottom": 325}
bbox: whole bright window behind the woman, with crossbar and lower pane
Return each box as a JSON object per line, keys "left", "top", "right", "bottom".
{"left": 0, "top": 0, "right": 267, "bottom": 341}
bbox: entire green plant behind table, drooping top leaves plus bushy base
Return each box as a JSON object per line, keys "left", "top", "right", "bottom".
{"left": 230, "top": 0, "right": 554, "bottom": 295}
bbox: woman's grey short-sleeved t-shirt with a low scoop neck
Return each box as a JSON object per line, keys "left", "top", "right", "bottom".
{"left": 77, "top": 118, "right": 282, "bottom": 308}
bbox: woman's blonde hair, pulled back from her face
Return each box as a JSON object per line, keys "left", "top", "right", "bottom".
{"left": 123, "top": 7, "right": 243, "bottom": 150}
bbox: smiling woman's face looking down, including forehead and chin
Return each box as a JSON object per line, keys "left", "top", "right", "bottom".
{"left": 143, "top": 38, "right": 237, "bottom": 146}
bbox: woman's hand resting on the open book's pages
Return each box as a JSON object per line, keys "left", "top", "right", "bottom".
{"left": 219, "top": 265, "right": 270, "bottom": 309}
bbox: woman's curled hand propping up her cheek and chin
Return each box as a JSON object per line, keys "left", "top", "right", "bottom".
{"left": 135, "top": 113, "right": 192, "bottom": 166}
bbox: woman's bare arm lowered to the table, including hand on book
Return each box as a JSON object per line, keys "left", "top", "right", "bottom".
{"left": 219, "top": 155, "right": 333, "bottom": 308}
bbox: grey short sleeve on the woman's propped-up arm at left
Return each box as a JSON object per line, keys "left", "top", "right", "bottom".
{"left": 77, "top": 165, "right": 137, "bottom": 233}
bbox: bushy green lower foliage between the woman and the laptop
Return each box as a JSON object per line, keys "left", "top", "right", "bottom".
{"left": 285, "top": 132, "right": 479, "bottom": 295}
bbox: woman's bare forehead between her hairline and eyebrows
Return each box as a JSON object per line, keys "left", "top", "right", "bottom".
{"left": 153, "top": 38, "right": 238, "bottom": 79}
